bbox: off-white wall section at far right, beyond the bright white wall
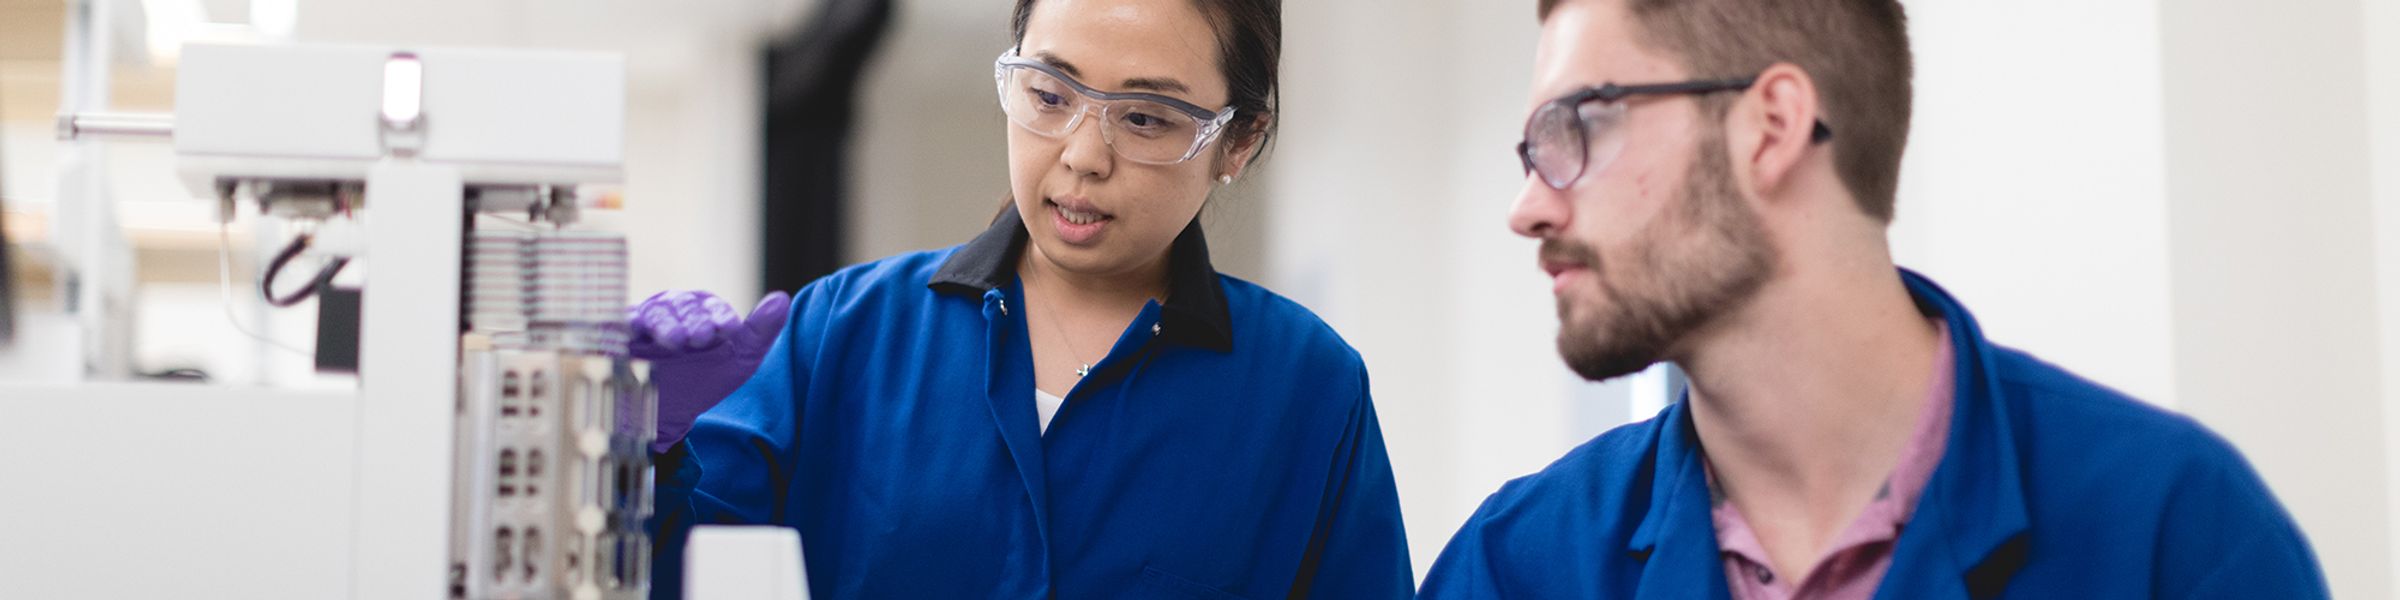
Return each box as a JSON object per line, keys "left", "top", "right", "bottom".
{"left": 2160, "top": 0, "right": 2393, "bottom": 598}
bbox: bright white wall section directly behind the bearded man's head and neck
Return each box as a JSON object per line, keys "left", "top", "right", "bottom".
{"left": 1891, "top": 0, "right": 2174, "bottom": 406}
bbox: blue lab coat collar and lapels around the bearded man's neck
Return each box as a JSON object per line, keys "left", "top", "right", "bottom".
{"left": 1625, "top": 269, "right": 2030, "bottom": 598}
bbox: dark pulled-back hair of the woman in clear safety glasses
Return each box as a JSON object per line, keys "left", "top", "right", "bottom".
{"left": 1008, "top": 0, "right": 1284, "bottom": 168}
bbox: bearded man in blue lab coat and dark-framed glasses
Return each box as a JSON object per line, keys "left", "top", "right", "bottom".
{"left": 1421, "top": 0, "right": 2326, "bottom": 598}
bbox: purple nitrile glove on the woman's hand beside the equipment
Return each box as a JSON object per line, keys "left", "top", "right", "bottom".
{"left": 624, "top": 290, "right": 792, "bottom": 451}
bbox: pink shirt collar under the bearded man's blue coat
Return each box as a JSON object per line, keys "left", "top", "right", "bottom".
{"left": 1709, "top": 324, "right": 1956, "bottom": 600}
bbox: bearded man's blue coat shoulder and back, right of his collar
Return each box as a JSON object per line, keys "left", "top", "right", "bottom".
{"left": 1992, "top": 346, "right": 2326, "bottom": 598}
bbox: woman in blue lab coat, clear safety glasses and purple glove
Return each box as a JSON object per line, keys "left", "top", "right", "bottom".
{"left": 634, "top": 0, "right": 1411, "bottom": 598}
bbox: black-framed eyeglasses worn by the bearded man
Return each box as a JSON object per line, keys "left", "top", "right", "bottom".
{"left": 1517, "top": 77, "right": 1834, "bottom": 190}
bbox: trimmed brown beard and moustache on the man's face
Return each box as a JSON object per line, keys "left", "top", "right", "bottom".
{"left": 1541, "top": 127, "right": 1776, "bottom": 382}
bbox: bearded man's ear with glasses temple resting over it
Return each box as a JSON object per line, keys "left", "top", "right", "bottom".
{"left": 1728, "top": 62, "right": 1819, "bottom": 197}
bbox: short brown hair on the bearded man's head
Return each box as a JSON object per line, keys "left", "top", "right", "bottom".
{"left": 1538, "top": 0, "right": 1915, "bottom": 223}
